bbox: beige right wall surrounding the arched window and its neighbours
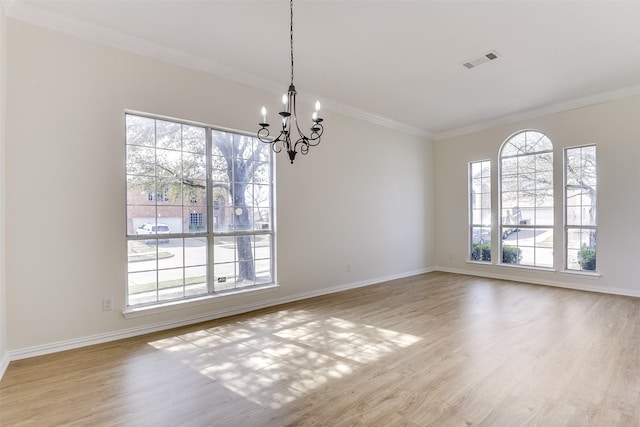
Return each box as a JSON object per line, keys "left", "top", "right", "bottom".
{"left": 434, "top": 96, "right": 640, "bottom": 296}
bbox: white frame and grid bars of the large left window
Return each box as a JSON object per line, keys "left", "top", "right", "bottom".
{"left": 124, "top": 110, "right": 277, "bottom": 312}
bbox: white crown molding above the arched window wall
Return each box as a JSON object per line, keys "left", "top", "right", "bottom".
{"left": 433, "top": 86, "right": 640, "bottom": 141}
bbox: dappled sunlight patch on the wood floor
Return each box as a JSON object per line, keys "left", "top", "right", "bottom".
{"left": 149, "top": 310, "right": 421, "bottom": 409}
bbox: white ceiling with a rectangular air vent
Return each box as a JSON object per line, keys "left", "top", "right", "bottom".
{"left": 3, "top": 0, "right": 640, "bottom": 139}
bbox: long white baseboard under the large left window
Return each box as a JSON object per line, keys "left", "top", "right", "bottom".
{"left": 3, "top": 268, "right": 435, "bottom": 362}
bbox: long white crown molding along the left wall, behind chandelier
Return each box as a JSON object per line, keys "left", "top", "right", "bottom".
{"left": 6, "top": 0, "right": 432, "bottom": 139}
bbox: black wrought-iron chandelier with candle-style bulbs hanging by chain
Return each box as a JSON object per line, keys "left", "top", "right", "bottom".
{"left": 257, "top": 0, "right": 324, "bottom": 164}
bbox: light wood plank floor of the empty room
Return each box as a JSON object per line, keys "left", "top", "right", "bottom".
{"left": 0, "top": 273, "right": 640, "bottom": 427}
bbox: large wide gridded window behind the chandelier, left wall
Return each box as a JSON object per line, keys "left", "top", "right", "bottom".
{"left": 126, "top": 114, "right": 273, "bottom": 306}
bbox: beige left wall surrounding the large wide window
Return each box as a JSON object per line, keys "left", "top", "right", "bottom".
{"left": 7, "top": 19, "right": 434, "bottom": 358}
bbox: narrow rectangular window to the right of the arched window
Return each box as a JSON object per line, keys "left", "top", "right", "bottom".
{"left": 564, "top": 145, "right": 598, "bottom": 271}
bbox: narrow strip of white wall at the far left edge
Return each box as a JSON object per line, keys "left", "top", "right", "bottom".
{"left": 0, "top": 5, "right": 9, "bottom": 378}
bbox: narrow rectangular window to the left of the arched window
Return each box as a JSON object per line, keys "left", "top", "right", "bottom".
{"left": 469, "top": 160, "right": 491, "bottom": 262}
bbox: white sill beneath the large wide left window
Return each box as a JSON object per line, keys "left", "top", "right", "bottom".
{"left": 122, "top": 283, "right": 280, "bottom": 319}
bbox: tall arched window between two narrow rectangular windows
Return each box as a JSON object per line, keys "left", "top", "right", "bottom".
{"left": 499, "top": 130, "right": 553, "bottom": 267}
